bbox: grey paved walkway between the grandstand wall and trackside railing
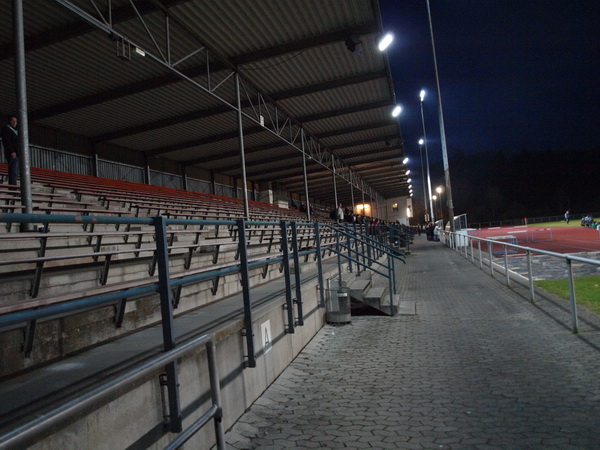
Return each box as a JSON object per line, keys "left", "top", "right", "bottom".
{"left": 225, "top": 236, "right": 600, "bottom": 449}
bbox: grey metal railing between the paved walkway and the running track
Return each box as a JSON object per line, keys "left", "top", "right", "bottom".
{"left": 445, "top": 231, "right": 600, "bottom": 333}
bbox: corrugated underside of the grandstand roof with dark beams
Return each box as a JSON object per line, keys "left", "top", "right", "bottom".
{"left": 0, "top": 0, "right": 408, "bottom": 203}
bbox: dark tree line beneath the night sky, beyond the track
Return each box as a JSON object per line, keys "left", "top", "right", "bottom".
{"left": 413, "top": 149, "right": 600, "bottom": 223}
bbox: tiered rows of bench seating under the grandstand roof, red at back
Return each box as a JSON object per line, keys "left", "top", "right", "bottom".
{"left": 0, "top": 165, "right": 334, "bottom": 376}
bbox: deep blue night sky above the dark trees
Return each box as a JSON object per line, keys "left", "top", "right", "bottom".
{"left": 380, "top": 0, "right": 600, "bottom": 169}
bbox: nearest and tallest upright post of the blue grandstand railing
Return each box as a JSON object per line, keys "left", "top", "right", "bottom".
{"left": 154, "top": 216, "right": 182, "bottom": 433}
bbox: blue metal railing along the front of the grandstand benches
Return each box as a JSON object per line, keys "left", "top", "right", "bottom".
{"left": 0, "top": 214, "right": 404, "bottom": 446}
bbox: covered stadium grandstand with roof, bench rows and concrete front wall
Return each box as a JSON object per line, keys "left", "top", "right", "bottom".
{"left": 0, "top": 0, "right": 412, "bottom": 449}
